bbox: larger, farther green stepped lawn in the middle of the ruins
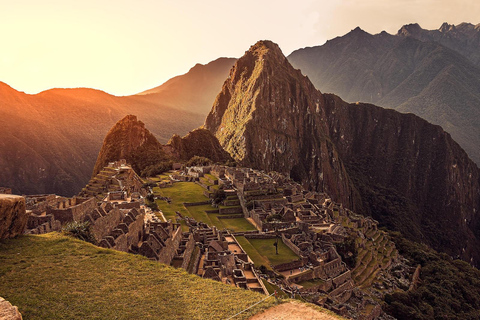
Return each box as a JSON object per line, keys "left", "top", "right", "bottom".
{"left": 153, "top": 182, "right": 255, "bottom": 232}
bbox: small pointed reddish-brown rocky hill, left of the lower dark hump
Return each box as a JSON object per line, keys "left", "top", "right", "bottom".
{"left": 93, "top": 115, "right": 168, "bottom": 175}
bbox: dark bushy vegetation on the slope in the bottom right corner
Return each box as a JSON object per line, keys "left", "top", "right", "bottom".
{"left": 384, "top": 232, "right": 480, "bottom": 320}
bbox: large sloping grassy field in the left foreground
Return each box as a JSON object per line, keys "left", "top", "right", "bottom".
{"left": 0, "top": 233, "right": 276, "bottom": 319}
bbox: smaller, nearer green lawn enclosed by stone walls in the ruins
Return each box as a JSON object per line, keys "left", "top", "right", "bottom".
{"left": 237, "top": 237, "right": 298, "bottom": 268}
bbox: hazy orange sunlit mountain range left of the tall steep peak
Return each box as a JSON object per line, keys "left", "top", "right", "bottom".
{"left": 0, "top": 59, "right": 233, "bottom": 196}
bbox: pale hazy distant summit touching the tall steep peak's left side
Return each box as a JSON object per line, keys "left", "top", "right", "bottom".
{"left": 139, "top": 58, "right": 237, "bottom": 115}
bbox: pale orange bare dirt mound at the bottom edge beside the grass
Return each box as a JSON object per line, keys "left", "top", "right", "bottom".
{"left": 249, "top": 301, "right": 340, "bottom": 320}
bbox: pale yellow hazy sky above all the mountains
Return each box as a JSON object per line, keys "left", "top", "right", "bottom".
{"left": 0, "top": 0, "right": 480, "bottom": 95}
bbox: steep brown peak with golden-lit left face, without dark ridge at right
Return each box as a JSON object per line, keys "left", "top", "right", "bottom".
{"left": 205, "top": 41, "right": 355, "bottom": 207}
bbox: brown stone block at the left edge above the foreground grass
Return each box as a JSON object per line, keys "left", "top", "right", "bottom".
{"left": 0, "top": 194, "right": 28, "bottom": 239}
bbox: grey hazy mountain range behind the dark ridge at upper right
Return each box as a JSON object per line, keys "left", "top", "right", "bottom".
{"left": 288, "top": 24, "right": 480, "bottom": 164}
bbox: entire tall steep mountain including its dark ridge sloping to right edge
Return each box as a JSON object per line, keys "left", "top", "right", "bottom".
{"left": 205, "top": 41, "right": 480, "bottom": 265}
